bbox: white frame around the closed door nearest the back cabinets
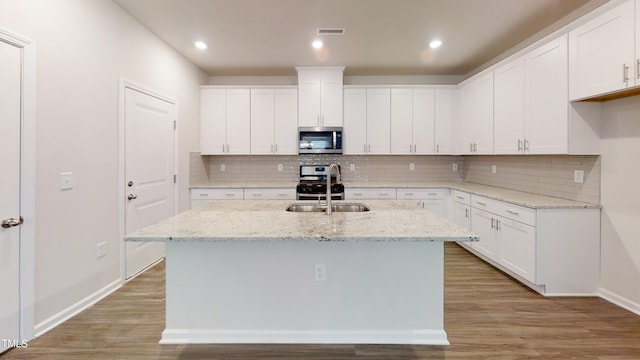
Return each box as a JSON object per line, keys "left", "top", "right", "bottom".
{"left": 118, "top": 77, "right": 180, "bottom": 282}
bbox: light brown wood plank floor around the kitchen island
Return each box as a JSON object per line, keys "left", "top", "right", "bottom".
{"left": 0, "top": 244, "right": 640, "bottom": 360}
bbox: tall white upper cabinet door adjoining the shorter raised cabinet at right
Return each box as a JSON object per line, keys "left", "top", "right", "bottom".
{"left": 524, "top": 35, "right": 569, "bottom": 154}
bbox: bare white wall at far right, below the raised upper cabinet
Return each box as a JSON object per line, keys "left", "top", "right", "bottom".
{"left": 601, "top": 96, "right": 640, "bottom": 313}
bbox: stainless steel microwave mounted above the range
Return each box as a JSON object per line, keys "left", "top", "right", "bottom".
{"left": 298, "top": 126, "right": 343, "bottom": 154}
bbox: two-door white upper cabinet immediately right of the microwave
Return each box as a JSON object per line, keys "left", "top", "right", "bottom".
{"left": 342, "top": 88, "right": 391, "bottom": 155}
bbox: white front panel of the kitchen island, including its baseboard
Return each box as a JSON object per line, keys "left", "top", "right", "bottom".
{"left": 161, "top": 240, "right": 448, "bottom": 345}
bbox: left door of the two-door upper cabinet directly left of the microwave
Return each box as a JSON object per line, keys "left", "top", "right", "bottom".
{"left": 251, "top": 89, "right": 275, "bottom": 155}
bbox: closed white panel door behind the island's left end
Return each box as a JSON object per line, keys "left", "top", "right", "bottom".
{"left": 124, "top": 87, "right": 175, "bottom": 278}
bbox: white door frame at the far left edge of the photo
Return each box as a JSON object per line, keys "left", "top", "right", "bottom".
{"left": 0, "top": 28, "right": 36, "bottom": 340}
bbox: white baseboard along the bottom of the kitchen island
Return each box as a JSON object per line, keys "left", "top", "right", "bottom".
{"left": 160, "top": 329, "right": 449, "bottom": 345}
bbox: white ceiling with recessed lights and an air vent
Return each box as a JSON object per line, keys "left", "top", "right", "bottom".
{"left": 114, "top": 0, "right": 607, "bottom": 76}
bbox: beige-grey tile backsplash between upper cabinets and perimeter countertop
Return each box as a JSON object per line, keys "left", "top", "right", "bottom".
{"left": 190, "top": 153, "right": 600, "bottom": 204}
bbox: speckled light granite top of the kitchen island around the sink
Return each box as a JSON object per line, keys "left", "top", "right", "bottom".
{"left": 125, "top": 200, "right": 478, "bottom": 242}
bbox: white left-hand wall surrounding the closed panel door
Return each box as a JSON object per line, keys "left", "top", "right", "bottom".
{"left": 0, "top": 0, "right": 208, "bottom": 331}
